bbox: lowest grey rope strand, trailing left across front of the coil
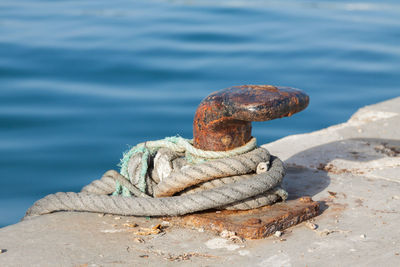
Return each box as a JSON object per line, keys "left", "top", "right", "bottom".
{"left": 26, "top": 156, "right": 285, "bottom": 219}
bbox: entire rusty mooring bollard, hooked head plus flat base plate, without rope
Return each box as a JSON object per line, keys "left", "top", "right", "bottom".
{"left": 175, "top": 85, "right": 319, "bottom": 239}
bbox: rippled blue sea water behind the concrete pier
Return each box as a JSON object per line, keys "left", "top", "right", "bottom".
{"left": 0, "top": 0, "right": 400, "bottom": 227}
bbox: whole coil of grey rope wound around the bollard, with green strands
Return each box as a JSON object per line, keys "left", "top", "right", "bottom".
{"left": 25, "top": 137, "right": 287, "bottom": 217}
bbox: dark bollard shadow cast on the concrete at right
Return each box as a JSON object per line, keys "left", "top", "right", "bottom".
{"left": 282, "top": 138, "right": 400, "bottom": 213}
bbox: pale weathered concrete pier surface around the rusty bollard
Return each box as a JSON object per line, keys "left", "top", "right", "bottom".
{"left": 0, "top": 97, "right": 400, "bottom": 266}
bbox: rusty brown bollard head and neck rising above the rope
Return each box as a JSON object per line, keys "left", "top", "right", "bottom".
{"left": 193, "top": 85, "right": 309, "bottom": 151}
